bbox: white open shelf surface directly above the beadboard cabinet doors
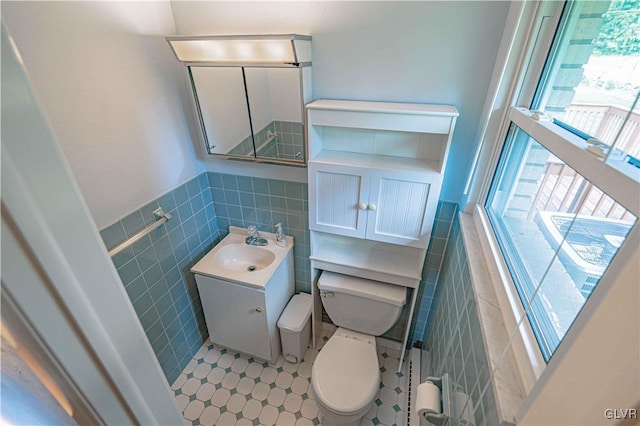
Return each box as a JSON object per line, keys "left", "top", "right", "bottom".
{"left": 309, "top": 150, "right": 440, "bottom": 173}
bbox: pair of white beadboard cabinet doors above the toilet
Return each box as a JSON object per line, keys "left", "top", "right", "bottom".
{"left": 309, "top": 161, "right": 442, "bottom": 248}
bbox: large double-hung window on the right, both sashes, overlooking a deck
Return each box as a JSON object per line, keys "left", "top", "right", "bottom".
{"left": 484, "top": 1, "right": 640, "bottom": 362}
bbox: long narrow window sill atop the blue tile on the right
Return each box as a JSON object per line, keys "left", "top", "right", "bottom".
{"left": 460, "top": 213, "right": 525, "bottom": 424}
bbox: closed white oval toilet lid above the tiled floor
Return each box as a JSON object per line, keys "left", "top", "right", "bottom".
{"left": 311, "top": 336, "right": 380, "bottom": 414}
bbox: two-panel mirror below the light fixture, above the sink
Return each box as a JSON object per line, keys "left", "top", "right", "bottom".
{"left": 189, "top": 66, "right": 306, "bottom": 165}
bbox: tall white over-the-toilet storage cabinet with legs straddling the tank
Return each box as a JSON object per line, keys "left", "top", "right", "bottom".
{"left": 306, "top": 100, "right": 458, "bottom": 370}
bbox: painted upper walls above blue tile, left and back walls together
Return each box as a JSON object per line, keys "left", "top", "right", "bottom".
{"left": 2, "top": 1, "right": 508, "bottom": 220}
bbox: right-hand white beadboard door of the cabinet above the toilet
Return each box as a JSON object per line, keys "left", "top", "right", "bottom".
{"left": 366, "top": 170, "right": 441, "bottom": 248}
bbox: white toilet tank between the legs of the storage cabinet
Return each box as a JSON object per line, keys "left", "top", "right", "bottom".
{"left": 318, "top": 271, "right": 407, "bottom": 336}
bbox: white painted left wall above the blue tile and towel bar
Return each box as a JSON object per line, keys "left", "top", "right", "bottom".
{"left": 2, "top": 1, "right": 204, "bottom": 228}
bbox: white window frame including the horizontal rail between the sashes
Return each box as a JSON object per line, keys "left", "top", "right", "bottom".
{"left": 464, "top": 1, "right": 640, "bottom": 393}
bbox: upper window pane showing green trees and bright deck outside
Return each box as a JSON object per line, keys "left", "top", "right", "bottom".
{"left": 532, "top": 0, "right": 640, "bottom": 158}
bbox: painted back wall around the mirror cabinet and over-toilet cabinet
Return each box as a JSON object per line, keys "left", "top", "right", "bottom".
{"left": 172, "top": 1, "right": 509, "bottom": 201}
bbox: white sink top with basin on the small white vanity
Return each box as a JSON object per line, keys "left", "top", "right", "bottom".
{"left": 191, "top": 226, "right": 293, "bottom": 288}
